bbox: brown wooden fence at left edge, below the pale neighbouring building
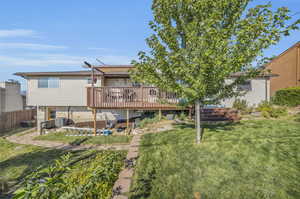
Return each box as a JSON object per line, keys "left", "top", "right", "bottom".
{"left": 0, "top": 109, "right": 36, "bottom": 132}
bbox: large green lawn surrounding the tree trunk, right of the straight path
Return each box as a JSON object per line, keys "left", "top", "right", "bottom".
{"left": 130, "top": 120, "right": 300, "bottom": 199}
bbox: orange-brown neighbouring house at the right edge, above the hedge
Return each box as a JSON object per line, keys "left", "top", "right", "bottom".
{"left": 266, "top": 42, "right": 300, "bottom": 96}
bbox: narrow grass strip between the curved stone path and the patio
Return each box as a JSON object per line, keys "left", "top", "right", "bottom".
{"left": 35, "top": 132, "right": 132, "bottom": 145}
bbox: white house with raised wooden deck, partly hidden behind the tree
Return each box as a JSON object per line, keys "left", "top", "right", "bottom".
{"left": 15, "top": 65, "right": 270, "bottom": 131}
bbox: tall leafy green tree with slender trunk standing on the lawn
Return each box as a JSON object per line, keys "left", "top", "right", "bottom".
{"left": 131, "top": 0, "right": 300, "bottom": 143}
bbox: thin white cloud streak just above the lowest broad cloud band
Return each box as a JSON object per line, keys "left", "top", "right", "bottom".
{"left": 0, "top": 43, "right": 68, "bottom": 50}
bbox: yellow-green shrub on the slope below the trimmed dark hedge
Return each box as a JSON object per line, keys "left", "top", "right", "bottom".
{"left": 256, "top": 101, "right": 288, "bottom": 118}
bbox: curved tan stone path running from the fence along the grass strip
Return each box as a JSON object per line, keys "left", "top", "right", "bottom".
{"left": 6, "top": 130, "right": 129, "bottom": 150}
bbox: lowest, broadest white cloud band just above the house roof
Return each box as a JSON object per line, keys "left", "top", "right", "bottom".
{"left": 0, "top": 54, "right": 131, "bottom": 67}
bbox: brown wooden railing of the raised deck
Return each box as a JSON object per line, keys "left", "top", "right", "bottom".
{"left": 87, "top": 87, "right": 179, "bottom": 109}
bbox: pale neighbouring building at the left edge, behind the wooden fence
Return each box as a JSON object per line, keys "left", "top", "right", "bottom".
{"left": 0, "top": 80, "right": 23, "bottom": 114}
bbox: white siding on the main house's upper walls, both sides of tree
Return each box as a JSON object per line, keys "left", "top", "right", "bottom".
{"left": 27, "top": 76, "right": 270, "bottom": 109}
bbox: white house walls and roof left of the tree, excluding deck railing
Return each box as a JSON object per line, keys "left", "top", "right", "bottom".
{"left": 16, "top": 66, "right": 145, "bottom": 131}
